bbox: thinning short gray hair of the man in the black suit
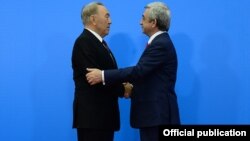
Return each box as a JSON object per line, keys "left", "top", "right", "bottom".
{"left": 81, "top": 2, "right": 104, "bottom": 25}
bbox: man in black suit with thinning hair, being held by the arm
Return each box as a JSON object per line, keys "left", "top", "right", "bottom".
{"left": 72, "top": 2, "right": 131, "bottom": 141}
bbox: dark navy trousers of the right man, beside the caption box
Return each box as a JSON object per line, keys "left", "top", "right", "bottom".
{"left": 140, "top": 126, "right": 159, "bottom": 141}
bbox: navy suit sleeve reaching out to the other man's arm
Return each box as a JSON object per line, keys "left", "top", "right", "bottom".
{"left": 104, "top": 43, "right": 168, "bottom": 84}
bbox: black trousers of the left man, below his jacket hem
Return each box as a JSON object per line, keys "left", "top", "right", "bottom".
{"left": 77, "top": 128, "right": 114, "bottom": 141}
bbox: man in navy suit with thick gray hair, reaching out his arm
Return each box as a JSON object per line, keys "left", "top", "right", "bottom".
{"left": 86, "top": 2, "right": 180, "bottom": 141}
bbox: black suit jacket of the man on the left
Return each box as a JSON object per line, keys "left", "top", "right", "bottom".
{"left": 72, "top": 29, "right": 124, "bottom": 130}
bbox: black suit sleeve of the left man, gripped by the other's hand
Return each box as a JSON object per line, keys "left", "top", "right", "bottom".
{"left": 72, "top": 37, "right": 124, "bottom": 97}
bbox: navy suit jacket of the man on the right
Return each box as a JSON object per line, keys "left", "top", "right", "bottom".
{"left": 104, "top": 33, "right": 180, "bottom": 128}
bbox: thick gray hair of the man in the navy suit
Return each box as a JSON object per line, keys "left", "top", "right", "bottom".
{"left": 145, "top": 2, "right": 171, "bottom": 31}
